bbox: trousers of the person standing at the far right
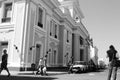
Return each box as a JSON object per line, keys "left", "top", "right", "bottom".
{"left": 107, "top": 62, "right": 117, "bottom": 80}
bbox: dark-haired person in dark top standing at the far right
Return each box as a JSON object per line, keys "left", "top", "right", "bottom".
{"left": 107, "top": 45, "right": 118, "bottom": 80}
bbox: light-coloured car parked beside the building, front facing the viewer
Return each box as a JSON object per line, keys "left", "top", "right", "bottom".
{"left": 70, "top": 61, "right": 88, "bottom": 73}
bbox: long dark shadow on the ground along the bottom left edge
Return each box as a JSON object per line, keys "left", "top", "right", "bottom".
{"left": 0, "top": 75, "right": 57, "bottom": 80}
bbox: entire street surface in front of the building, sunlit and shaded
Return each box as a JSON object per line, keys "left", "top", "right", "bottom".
{"left": 0, "top": 70, "right": 120, "bottom": 80}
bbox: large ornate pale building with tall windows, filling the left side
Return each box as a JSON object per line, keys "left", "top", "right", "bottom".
{"left": 0, "top": 0, "right": 92, "bottom": 70}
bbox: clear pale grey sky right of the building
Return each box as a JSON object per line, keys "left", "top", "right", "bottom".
{"left": 79, "top": 0, "right": 120, "bottom": 62}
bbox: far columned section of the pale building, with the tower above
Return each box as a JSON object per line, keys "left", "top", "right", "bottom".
{"left": 60, "top": 0, "right": 89, "bottom": 62}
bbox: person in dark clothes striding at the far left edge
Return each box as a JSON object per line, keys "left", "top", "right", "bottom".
{"left": 0, "top": 49, "right": 10, "bottom": 77}
